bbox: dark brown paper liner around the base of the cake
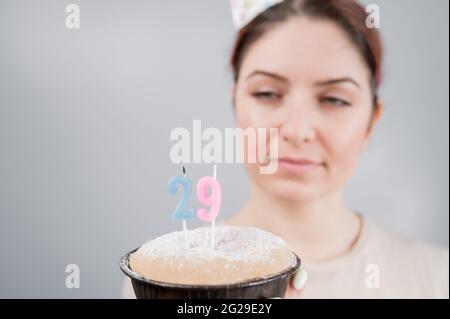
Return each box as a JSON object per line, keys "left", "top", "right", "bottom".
{"left": 120, "top": 249, "right": 301, "bottom": 299}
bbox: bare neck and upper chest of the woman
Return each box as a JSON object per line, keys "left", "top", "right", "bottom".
{"left": 228, "top": 185, "right": 361, "bottom": 261}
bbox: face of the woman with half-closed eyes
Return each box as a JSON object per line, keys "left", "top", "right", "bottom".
{"left": 233, "top": 17, "right": 381, "bottom": 202}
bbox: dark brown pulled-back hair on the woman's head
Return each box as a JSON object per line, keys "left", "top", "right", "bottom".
{"left": 231, "top": 0, "right": 383, "bottom": 105}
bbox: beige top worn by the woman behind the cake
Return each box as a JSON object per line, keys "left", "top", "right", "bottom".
{"left": 122, "top": 220, "right": 449, "bottom": 298}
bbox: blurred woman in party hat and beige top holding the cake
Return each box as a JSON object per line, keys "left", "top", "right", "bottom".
{"left": 122, "top": 0, "right": 449, "bottom": 298}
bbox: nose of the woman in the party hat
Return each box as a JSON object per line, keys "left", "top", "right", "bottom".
{"left": 280, "top": 105, "right": 316, "bottom": 146}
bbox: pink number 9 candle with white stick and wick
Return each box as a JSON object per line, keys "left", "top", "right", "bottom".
{"left": 197, "top": 166, "right": 222, "bottom": 248}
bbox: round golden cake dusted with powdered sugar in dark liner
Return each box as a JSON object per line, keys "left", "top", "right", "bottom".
{"left": 130, "top": 226, "right": 295, "bottom": 285}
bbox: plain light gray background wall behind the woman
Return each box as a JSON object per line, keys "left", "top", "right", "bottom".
{"left": 0, "top": 0, "right": 449, "bottom": 298}
